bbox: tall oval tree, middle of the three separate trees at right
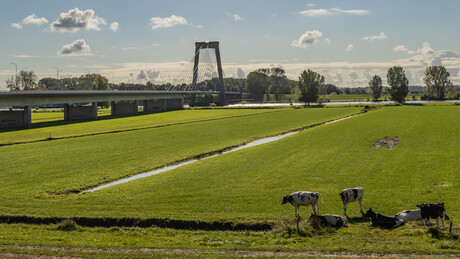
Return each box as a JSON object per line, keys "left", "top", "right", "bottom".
{"left": 386, "top": 66, "right": 409, "bottom": 103}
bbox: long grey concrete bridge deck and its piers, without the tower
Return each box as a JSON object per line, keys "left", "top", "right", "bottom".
{"left": 0, "top": 90, "right": 238, "bottom": 128}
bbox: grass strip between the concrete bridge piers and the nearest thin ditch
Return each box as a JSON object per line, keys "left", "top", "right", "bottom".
{"left": 0, "top": 109, "right": 279, "bottom": 145}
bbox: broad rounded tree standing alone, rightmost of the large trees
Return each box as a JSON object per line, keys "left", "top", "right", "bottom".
{"left": 423, "top": 66, "right": 453, "bottom": 100}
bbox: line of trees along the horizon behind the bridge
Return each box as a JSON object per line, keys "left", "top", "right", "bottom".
{"left": 6, "top": 66, "right": 459, "bottom": 103}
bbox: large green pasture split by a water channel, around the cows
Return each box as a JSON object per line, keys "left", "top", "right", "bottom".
{"left": 0, "top": 105, "right": 460, "bottom": 257}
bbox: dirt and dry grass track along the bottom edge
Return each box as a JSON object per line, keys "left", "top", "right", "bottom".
{"left": 0, "top": 245, "right": 460, "bottom": 258}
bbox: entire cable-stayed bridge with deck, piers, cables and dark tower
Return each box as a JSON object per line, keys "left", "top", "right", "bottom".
{"left": 0, "top": 41, "right": 240, "bottom": 128}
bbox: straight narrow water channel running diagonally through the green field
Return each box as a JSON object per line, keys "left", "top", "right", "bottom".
{"left": 77, "top": 113, "right": 361, "bottom": 195}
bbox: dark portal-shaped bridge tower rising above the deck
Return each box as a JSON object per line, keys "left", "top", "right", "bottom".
{"left": 192, "top": 41, "right": 227, "bottom": 106}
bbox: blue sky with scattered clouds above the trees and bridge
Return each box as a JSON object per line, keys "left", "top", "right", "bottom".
{"left": 0, "top": 0, "right": 460, "bottom": 90}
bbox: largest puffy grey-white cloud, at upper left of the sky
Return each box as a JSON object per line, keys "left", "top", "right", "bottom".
{"left": 51, "top": 8, "right": 106, "bottom": 32}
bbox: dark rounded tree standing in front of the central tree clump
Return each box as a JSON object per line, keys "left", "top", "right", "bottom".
{"left": 297, "top": 69, "right": 324, "bottom": 105}
